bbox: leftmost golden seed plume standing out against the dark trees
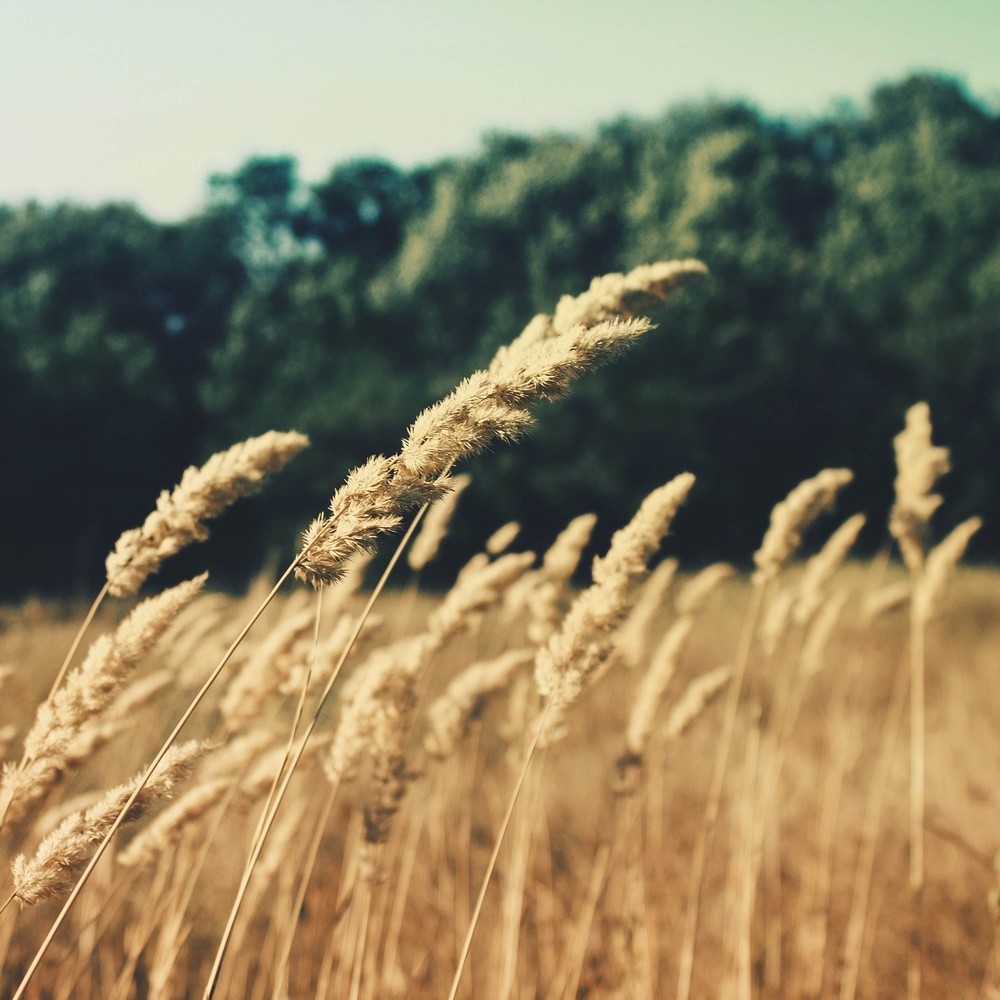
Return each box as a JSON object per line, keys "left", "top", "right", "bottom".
{"left": 106, "top": 431, "right": 309, "bottom": 597}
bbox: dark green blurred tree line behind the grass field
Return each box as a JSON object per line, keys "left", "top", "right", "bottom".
{"left": 0, "top": 75, "right": 1000, "bottom": 596}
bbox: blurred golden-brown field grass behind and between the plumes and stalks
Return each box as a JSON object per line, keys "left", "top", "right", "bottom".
{"left": 0, "top": 564, "right": 1000, "bottom": 997}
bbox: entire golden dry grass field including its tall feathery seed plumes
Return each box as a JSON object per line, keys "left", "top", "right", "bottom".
{"left": 0, "top": 262, "right": 1000, "bottom": 1000}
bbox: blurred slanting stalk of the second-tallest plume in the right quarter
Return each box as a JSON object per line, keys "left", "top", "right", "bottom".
{"left": 677, "top": 583, "right": 767, "bottom": 1000}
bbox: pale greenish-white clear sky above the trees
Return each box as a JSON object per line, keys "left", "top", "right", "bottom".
{"left": 0, "top": 0, "right": 1000, "bottom": 220}
